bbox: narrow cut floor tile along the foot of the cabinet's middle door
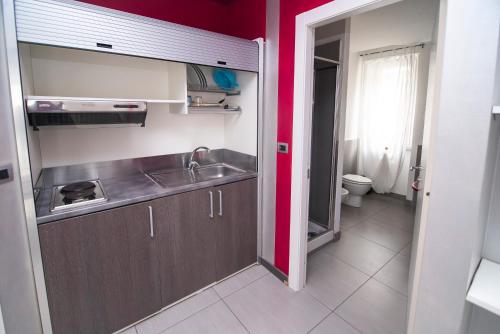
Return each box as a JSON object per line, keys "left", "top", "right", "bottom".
{"left": 136, "top": 288, "right": 220, "bottom": 334}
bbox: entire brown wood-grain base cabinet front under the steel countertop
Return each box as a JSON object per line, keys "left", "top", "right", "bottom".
{"left": 39, "top": 179, "right": 257, "bottom": 334}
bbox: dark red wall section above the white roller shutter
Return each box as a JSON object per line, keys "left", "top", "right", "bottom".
{"left": 76, "top": 0, "right": 266, "bottom": 39}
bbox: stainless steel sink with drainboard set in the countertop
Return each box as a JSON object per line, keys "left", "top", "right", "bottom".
{"left": 148, "top": 164, "right": 245, "bottom": 188}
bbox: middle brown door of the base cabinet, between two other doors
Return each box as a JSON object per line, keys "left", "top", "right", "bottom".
{"left": 154, "top": 188, "right": 216, "bottom": 305}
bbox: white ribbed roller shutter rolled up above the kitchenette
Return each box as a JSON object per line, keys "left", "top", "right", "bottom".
{"left": 15, "top": 0, "right": 259, "bottom": 72}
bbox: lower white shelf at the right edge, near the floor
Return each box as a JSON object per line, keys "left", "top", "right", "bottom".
{"left": 465, "top": 259, "right": 500, "bottom": 315}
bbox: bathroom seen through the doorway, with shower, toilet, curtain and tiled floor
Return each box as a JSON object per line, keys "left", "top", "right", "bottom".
{"left": 305, "top": 0, "right": 438, "bottom": 333}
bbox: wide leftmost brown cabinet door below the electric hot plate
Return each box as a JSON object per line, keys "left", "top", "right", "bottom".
{"left": 39, "top": 203, "right": 161, "bottom": 334}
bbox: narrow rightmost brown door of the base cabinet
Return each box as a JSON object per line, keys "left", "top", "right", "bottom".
{"left": 215, "top": 179, "right": 257, "bottom": 280}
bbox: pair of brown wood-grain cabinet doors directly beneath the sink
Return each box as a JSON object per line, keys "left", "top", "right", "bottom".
{"left": 154, "top": 179, "right": 257, "bottom": 305}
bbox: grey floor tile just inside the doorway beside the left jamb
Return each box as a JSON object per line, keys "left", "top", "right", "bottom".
{"left": 304, "top": 251, "right": 369, "bottom": 310}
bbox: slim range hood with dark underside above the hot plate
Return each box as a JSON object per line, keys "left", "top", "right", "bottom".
{"left": 26, "top": 96, "right": 147, "bottom": 129}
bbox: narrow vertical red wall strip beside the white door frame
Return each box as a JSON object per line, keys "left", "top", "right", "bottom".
{"left": 275, "top": 0, "right": 330, "bottom": 274}
